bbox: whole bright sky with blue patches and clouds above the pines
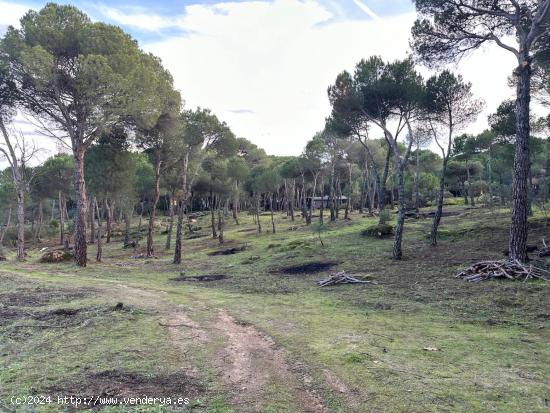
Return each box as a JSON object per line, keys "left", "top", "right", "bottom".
{"left": 0, "top": 0, "right": 528, "bottom": 155}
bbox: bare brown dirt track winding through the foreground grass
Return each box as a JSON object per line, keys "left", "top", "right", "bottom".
{"left": 108, "top": 284, "right": 329, "bottom": 413}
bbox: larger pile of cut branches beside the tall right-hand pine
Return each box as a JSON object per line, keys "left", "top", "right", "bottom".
{"left": 457, "top": 260, "right": 550, "bottom": 282}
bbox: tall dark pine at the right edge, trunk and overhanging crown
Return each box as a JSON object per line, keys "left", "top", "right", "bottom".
{"left": 411, "top": 0, "right": 550, "bottom": 261}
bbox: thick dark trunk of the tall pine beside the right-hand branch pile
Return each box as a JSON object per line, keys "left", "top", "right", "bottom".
{"left": 509, "top": 61, "right": 531, "bottom": 262}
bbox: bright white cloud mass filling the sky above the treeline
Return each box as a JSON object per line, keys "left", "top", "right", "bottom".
{"left": 137, "top": 0, "right": 514, "bottom": 155}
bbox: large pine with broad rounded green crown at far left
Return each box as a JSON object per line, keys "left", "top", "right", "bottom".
{"left": 0, "top": 3, "right": 167, "bottom": 266}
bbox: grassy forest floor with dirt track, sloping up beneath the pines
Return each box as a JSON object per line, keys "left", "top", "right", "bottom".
{"left": 0, "top": 206, "right": 550, "bottom": 413}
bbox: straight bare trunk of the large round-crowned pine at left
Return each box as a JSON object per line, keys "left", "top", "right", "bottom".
{"left": 74, "top": 148, "right": 88, "bottom": 267}
